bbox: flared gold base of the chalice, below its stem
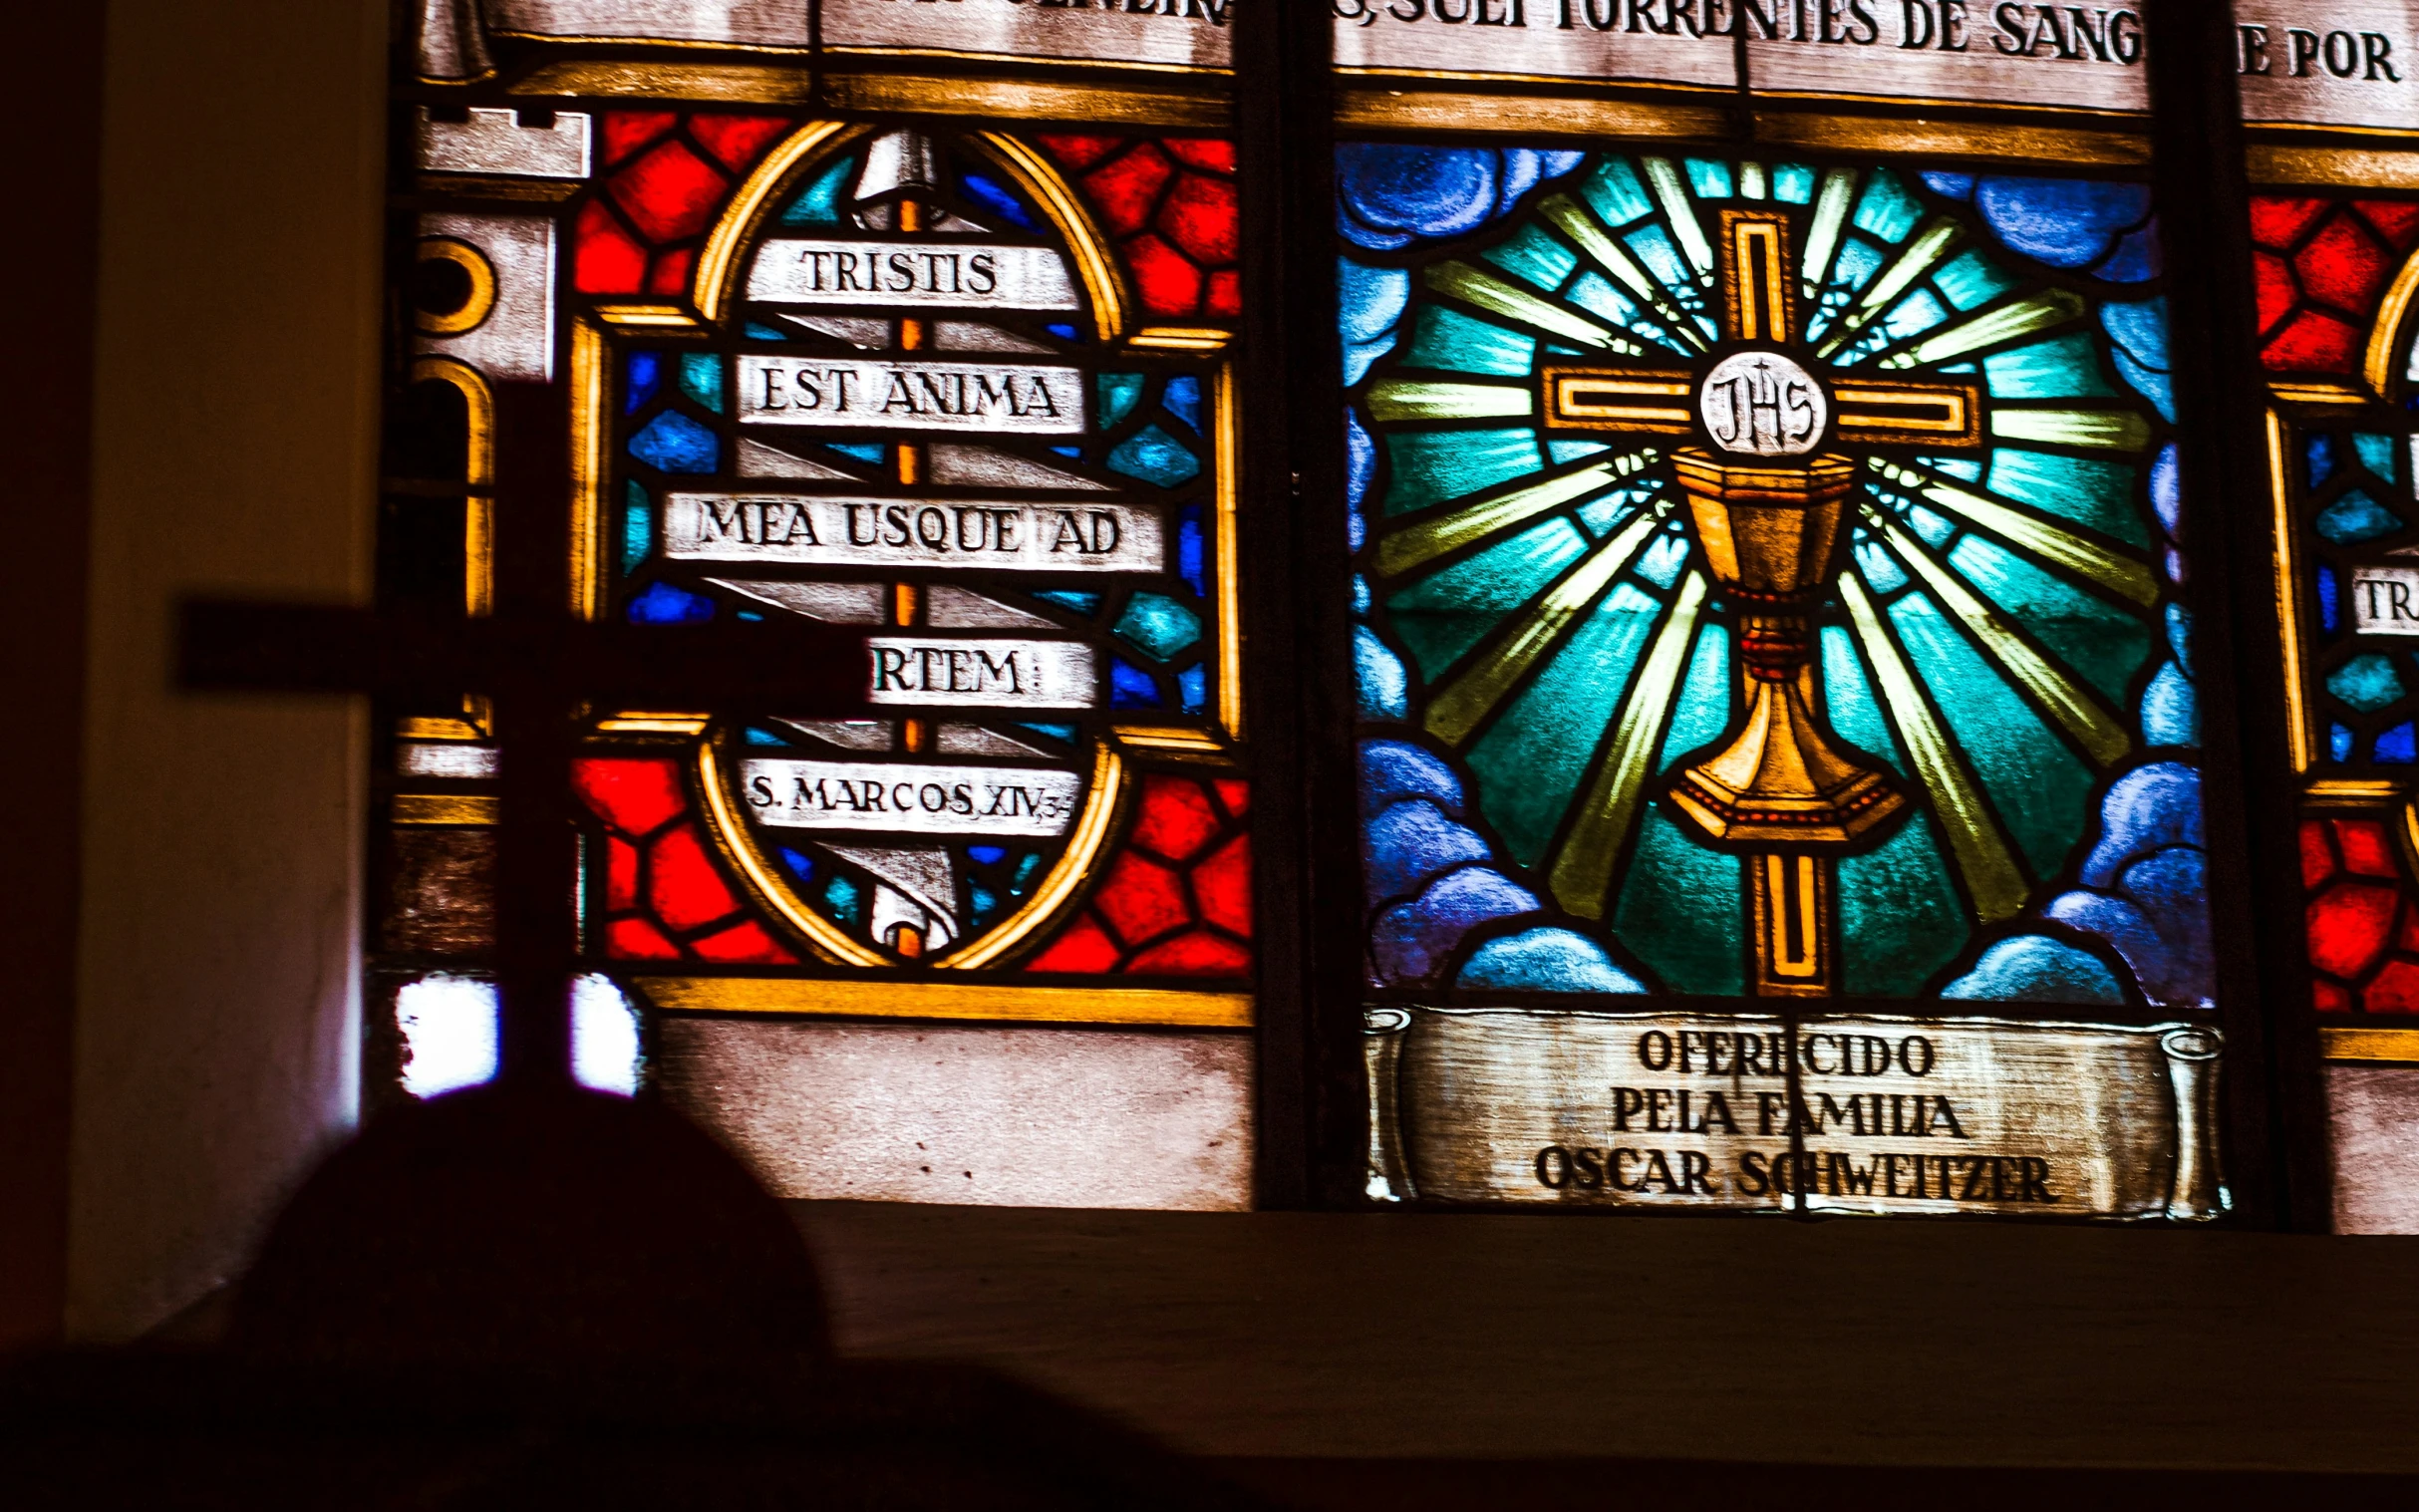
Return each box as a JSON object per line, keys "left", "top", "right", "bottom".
{"left": 1669, "top": 680, "right": 1906, "bottom": 849}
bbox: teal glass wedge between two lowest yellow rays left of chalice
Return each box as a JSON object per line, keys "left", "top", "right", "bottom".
{"left": 1468, "top": 583, "right": 1664, "bottom": 866}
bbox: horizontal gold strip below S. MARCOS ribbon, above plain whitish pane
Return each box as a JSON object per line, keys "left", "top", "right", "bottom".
{"left": 631, "top": 978, "right": 1256, "bottom": 1029}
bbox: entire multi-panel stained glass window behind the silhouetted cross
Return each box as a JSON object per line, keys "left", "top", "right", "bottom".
{"left": 370, "top": 0, "right": 2419, "bottom": 1227}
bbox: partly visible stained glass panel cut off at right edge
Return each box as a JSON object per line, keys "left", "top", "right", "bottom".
{"left": 2236, "top": 0, "right": 2419, "bottom": 1231}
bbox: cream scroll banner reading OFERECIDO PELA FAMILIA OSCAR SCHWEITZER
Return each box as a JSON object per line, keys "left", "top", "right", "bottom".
{"left": 1364, "top": 1009, "right": 2228, "bottom": 1219}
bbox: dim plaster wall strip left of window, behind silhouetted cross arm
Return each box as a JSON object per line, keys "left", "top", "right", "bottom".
{"left": 69, "top": 0, "right": 387, "bottom": 1341}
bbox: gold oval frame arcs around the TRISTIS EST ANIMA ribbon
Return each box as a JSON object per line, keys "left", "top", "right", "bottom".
{"left": 692, "top": 132, "right": 1132, "bottom": 970}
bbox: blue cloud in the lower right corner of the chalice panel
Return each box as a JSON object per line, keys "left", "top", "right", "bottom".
{"left": 1940, "top": 762, "right": 2216, "bottom": 1009}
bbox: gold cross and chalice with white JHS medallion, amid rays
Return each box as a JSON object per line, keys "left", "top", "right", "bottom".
{"left": 1541, "top": 210, "right": 1981, "bottom": 995}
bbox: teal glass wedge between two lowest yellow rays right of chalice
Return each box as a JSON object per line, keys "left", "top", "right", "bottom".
{"left": 1889, "top": 593, "right": 2092, "bottom": 876}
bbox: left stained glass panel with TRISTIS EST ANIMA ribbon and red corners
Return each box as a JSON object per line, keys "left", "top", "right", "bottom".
{"left": 378, "top": 0, "right": 1256, "bottom": 1207}
